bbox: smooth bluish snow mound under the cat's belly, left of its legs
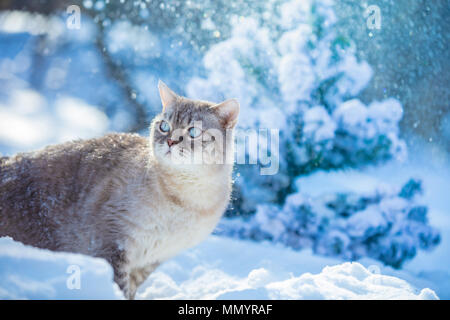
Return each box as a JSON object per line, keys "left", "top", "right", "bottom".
{"left": 0, "top": 238, "right": 122, "bottom": 300}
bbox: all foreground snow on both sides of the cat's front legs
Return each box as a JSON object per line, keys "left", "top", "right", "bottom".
{"left": 0, "top": 236, "right": 438, "bottom": 299}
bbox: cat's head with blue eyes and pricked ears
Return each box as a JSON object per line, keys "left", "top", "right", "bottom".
{"left": 150, "top": 81, "right": 239, "bottom": 170}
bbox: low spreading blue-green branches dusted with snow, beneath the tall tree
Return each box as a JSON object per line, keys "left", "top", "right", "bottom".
{"left": 217, "top": 175, "right": 441, "bottom": 268}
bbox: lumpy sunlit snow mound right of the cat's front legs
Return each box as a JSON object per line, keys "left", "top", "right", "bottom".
{"left": 137, "top": 236, "right": 438, "bottom": 299}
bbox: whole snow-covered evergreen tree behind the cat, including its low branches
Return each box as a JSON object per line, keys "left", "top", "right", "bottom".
{"left": 186, "top": 0, "right": 439, "bottom": 267}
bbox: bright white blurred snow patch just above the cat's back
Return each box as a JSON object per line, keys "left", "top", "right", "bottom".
{"left": 0, "top": 89, "right": 109, "bottom": 154}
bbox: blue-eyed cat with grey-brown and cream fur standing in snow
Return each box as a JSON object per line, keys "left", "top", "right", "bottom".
{"left": 0, "top": 81, "right": 239, "bottom": 299}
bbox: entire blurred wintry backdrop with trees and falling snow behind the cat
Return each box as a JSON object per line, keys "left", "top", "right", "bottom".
{"left": 0, "top": 0, "right": 450, "bottom": 297}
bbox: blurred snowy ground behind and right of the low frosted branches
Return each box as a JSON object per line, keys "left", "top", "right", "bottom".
{"left": 297, "top": 156, "right": 450, "bottom": 299}
